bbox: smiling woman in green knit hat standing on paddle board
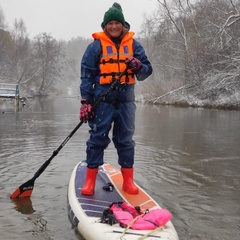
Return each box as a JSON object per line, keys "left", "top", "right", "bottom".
{"left": 80, "top": 3, "right": 152, "bottom": 195}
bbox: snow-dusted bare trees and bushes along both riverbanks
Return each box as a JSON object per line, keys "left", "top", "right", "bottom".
{"left": 0, "top": 0, "right": 240, "bottom": 109}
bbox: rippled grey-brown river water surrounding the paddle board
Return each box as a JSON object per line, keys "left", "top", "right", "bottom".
{"left": 0, "top": 98, "right": 240, "bottom": 240}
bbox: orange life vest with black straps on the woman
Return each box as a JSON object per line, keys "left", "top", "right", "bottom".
{"left": 92, "top": 32, "right": 136, "bottom": 84}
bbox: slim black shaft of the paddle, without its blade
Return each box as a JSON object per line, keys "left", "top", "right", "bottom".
{"left": 32, "top": 67, "right": 128, "bottom": 180}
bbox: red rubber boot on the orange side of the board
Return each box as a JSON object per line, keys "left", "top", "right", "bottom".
{"left": 121, "top": 168, "right": 139, "bottom": 194}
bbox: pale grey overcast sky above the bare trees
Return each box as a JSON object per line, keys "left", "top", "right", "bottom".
{"left": 0, "top": 0, "right": 157, "bottom": 40}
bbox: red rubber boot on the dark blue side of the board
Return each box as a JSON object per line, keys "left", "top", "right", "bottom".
{"left": 81, "top": 168, "right": 98, "bottom": 195}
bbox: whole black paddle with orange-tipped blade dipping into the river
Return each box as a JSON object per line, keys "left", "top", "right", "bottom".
{"left": 10, "top": 67, "right": 128, "bottom": 199}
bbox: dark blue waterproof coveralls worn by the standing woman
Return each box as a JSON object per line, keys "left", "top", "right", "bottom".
{"left": 80, "top": 34, "right": 152, "bottom": 168}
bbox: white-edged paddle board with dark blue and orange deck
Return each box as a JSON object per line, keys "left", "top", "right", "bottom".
{"left": 68, "top": 161, "right": 179, "bottom": 240}
